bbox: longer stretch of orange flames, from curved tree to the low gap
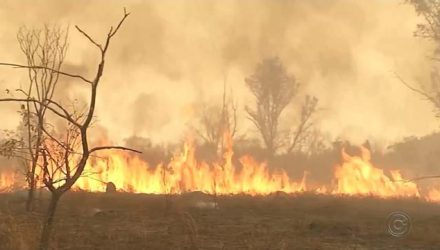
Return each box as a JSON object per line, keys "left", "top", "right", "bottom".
{"left": 75, "top": 139, "right": 305, "bottom": 195}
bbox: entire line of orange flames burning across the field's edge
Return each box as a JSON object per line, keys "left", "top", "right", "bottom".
{"left": 0, "top": 136, "right": 440, "bottom": 201}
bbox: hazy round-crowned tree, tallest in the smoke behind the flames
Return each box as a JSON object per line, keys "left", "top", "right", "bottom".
{"left": 245, "top": 57, "right": 299, "bottom": 157}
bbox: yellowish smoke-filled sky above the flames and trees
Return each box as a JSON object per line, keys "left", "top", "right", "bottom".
{"left": 0, "top": 0, "right": 438, "bottom": 147}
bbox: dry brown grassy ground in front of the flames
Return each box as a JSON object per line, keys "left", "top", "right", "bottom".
{"left": 0, "top": 192, "right": 440, "bottom": 250}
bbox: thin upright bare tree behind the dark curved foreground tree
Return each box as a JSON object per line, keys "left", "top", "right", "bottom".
{"left": 10, "top": 25, "right": 68, "bottom": 211}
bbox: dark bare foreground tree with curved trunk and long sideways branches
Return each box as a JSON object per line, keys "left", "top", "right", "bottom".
{"left": 0, "top": 9, "right": 140, "bottom": 250}
